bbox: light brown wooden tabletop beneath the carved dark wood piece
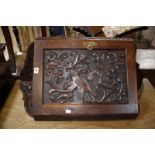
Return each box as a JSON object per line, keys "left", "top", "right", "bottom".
{"left": 0, "top": 79, "right": 155, "bottom": 129}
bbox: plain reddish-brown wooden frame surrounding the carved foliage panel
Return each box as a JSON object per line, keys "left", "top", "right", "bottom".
{"left": 32, "top": 38, "right": 139, "bottom": 119}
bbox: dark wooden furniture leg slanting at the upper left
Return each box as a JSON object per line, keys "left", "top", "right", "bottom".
{"left": 2, "top": 26, "right": 17, "bottom": 75}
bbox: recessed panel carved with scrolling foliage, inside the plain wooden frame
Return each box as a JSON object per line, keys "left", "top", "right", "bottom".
{"left": 43, "top": 49, "right": 128, "bottom": 104}
